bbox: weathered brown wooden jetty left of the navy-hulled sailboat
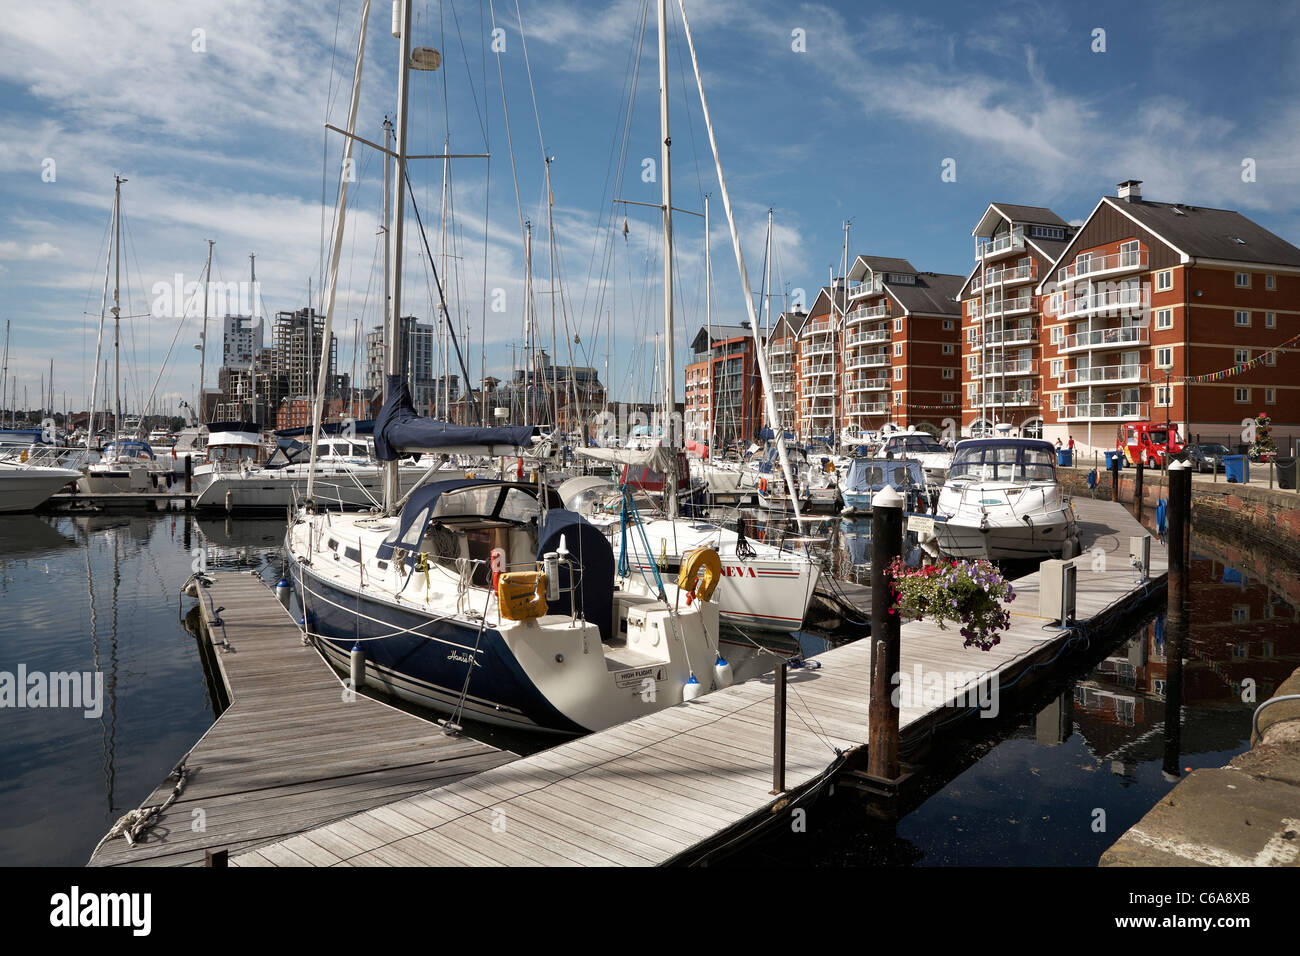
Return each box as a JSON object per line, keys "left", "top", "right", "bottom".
{"left": 90, "top": 572, "right": 516, "bottom": 866}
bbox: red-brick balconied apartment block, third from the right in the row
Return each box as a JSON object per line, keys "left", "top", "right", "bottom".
{"left": 841, "top": 256, "right": 962, "bottom": 434}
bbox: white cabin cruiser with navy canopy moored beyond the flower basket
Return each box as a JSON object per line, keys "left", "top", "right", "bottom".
{"left": 935, "top": 438, "right": 1079, "bottom": 559}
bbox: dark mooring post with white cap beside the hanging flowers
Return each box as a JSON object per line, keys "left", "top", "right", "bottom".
{"left": 867, "top": 485, "right": 904, "bottom": 780}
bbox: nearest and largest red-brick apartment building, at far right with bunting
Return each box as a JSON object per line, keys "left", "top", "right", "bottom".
{"left": 1035, "top": 179, "right": 1300, "bottom": 460}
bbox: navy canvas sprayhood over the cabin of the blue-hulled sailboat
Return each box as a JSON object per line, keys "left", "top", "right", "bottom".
{"left": 376, "top": 479, "right": 563, "bottom": 561}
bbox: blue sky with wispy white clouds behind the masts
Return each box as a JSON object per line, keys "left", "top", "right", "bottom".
{"left": 0, "top": 0, "right": 1300, "bottom": 411}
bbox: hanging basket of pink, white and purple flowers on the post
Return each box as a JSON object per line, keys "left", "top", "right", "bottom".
{"left": 888, "top": 558, "right": 1015, "bottom": 650}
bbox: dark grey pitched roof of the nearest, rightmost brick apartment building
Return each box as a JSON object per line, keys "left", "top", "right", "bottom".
{"left": 1102, "top": 196, "right": 1300, "bottom": 267}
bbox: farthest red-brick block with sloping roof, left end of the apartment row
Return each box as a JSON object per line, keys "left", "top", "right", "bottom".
{"left": 684, "top": 323, "right": 763, "bottom": 453}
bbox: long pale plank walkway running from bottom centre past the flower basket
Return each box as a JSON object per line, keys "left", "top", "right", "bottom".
{"left": 231, "top": 499, "right": 1167, "bottom": 866}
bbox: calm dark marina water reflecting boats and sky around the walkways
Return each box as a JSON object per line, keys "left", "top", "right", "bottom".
{"left": 0, "top": 514, "right": 1300, "bottom": 866}
